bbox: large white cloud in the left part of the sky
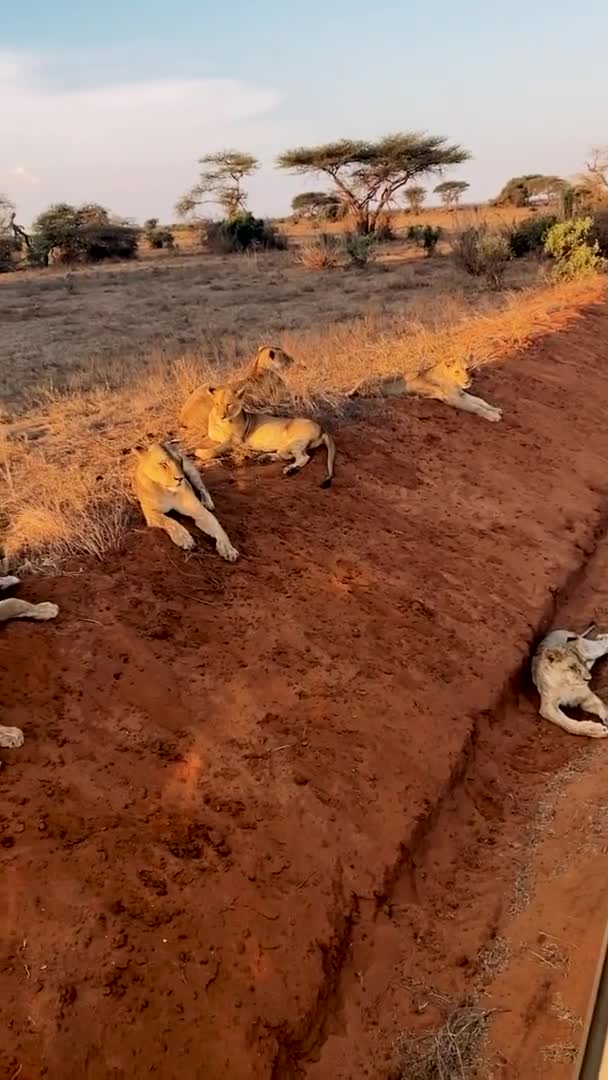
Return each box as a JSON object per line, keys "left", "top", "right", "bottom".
{"left": 0, "top": 52, "right": 279, "bottom": 220}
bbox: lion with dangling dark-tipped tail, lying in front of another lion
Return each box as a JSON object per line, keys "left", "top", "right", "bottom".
{"left": 194, "top": 387, "right": 336, "bottom": 487}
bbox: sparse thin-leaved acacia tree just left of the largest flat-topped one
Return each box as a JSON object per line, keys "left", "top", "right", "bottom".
{"left": 175, "top": 150, "right": 259, "bottom": 217}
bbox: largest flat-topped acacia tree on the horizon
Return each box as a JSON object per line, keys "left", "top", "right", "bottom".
{"left": 276, "top": 132, "right": 470, "bottom": 233}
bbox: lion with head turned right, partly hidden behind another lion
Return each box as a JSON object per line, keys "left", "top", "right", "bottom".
{"left": 179, "top": 345, "right": 295, "bottom": 436}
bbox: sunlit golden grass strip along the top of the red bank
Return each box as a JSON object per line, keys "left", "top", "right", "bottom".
{"left": 0, "top": 278, "right": 605, "bottom": 570}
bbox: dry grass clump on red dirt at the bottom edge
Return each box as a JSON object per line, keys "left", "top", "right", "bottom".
{"left": 391, "top": 998, "right": 490, "bottom": 1080}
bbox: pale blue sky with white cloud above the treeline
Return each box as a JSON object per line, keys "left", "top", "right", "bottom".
{"left": 0, "top": 0, "right": 608, "bottom": 220}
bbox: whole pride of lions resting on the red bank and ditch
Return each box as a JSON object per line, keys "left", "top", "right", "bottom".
{"left": 0, "top": 346, "right": 608, "bottom": 747}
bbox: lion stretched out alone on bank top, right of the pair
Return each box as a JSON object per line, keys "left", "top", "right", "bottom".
{"left": 349, "top": 361, "right": 502, "bottom": 423}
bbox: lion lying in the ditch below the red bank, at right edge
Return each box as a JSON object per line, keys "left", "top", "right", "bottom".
{"left": 531, "top": 626, "right": 608, "bottom": 739}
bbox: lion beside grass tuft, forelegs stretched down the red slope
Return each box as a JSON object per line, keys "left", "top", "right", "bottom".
{"left": 133, "top": 443, "right": 239, "bottom": 563}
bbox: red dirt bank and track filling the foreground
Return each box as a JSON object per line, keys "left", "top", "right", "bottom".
{"left": 0, "top": 300, "right": 608, "bottom": 1080}
